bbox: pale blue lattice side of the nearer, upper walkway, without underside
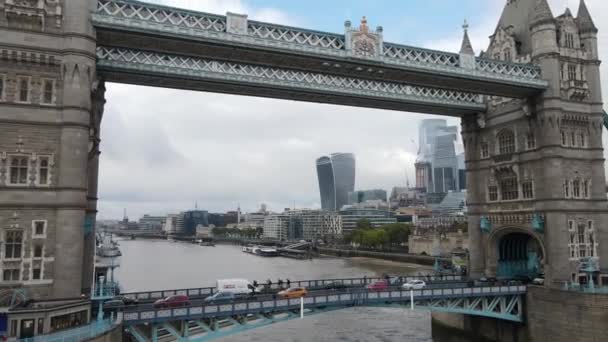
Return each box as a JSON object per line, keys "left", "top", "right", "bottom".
{"left": 92, "top": 0, "right": 548, "bottom": 90}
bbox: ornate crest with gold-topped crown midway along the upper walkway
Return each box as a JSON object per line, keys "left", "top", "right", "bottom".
{"left": 345, "top": 17, "right": 383, "bottom": 58}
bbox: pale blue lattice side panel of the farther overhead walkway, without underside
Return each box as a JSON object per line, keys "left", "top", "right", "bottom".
{"left": 97, "top": 47, "right": 485, "bottom": 111}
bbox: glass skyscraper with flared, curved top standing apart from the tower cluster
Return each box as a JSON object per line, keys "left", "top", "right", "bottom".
{"left": 317, "top": 153, "right": 355, "bottom": 211}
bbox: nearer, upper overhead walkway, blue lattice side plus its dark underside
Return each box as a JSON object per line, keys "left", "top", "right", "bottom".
{"left": 92, "top": 0, "right": 548, "bottom": 97}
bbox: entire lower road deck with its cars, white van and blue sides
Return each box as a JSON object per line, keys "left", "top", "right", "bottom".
{"left": 97, "top": 275, "right": 526, "bottom": 341}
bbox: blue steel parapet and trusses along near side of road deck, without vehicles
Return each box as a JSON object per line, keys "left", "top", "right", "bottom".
{"left": 122, "top": 286, "right": 526, "bottom": 341}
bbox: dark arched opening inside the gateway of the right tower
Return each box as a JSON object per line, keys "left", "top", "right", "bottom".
{"left": 497, "top": 232, "right": 544, "bottom": 279}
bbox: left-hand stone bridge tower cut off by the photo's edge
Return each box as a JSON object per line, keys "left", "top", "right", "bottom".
{"left": 0, "top": 0, "right": 103, "bottom": 298}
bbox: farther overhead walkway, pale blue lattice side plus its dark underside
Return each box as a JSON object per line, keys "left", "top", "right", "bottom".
{"left": 97, "top": 47, "right": 486, "bottom": 115}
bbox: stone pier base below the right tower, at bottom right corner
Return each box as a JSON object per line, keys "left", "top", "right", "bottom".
{"left": 432, "top": 286, "right": 608, "bottom": 342}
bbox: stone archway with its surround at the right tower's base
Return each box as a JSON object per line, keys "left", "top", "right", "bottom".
{"left": 486, "top": 228, "right": 546, "bottom": 279}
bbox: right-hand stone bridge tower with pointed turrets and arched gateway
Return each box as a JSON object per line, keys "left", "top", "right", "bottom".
{"left": 461, "top": 0, "right": 608, "bottom": 287}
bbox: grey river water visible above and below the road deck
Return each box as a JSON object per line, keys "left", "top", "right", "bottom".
{"left": 115, "top": 240, "right": 484, "bottom": 342}
